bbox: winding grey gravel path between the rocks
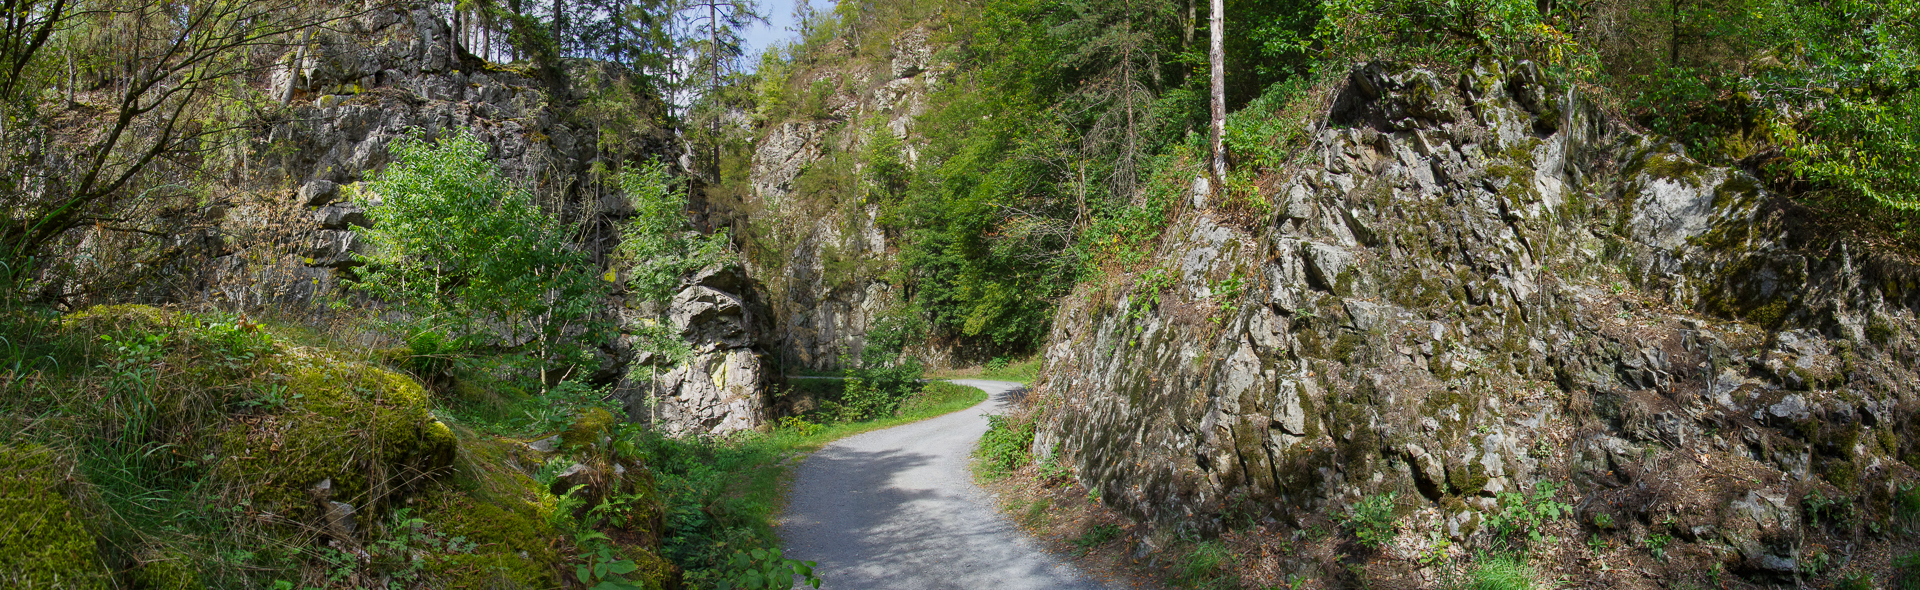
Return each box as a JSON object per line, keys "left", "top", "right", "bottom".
{"left": 780, "top": 379, "right": 1108, "bottom": 590}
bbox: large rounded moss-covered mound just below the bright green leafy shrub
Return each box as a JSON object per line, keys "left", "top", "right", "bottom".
{"left": 217, "top": 352, "right": 455, "bottom": 519}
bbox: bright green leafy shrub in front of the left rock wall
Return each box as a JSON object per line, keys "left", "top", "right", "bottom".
{"left": 351, "top": 131, "right": 607, "bottom": 373}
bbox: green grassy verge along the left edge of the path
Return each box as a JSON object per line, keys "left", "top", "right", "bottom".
{"left": 645, "top": 381, "right": 987, "bottom": 588}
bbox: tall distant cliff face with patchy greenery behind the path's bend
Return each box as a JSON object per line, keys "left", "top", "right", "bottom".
{"left": 743, "top": 29, "right": 948, "bottom": 369}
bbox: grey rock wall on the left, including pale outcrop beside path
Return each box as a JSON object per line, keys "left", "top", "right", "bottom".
{"left": 39, "top": 6, "right": 778, "bottom": 434}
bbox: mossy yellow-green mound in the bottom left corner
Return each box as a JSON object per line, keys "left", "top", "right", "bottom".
{"left": 0, "top": 446, "right": 109, "bottom": 588}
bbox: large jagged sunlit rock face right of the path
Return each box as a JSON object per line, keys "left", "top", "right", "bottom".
{"left": 1035, "top": 63, "right": 1920, "bottom": 575}
